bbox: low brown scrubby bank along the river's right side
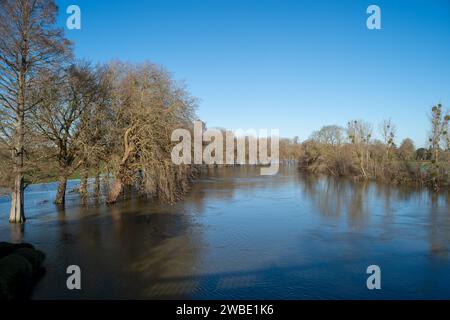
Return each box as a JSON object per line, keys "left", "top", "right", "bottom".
{"left": 299, "top": 141, "right": 450, "bottom": 191}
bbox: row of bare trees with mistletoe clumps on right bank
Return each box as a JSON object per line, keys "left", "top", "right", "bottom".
{"left": 299, "top": 104, "right": 450, "bottom": 189}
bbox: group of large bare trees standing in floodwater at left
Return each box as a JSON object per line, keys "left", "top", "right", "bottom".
{"left": 0, "top": 0, "right": 196, "bottom": 223}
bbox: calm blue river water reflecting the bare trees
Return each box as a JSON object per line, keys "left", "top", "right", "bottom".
{"left": 0, "top": 167, "right": 450, "bottom": 299}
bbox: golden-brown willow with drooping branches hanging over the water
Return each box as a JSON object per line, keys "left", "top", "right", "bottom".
{"left": 107, "top": 64, "right": 195, "bottom": 203}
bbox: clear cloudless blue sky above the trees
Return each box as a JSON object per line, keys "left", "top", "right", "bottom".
{"left": 57, "top": 0, "right": 450, "bottom": 145}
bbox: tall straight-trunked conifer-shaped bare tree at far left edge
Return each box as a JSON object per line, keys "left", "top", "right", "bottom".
{"left": 0, "top": 0, "right": 70, "bottom": 223}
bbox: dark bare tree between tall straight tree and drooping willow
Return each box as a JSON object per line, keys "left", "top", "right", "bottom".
{"left": 32, "top": 63, "right": 99, "bottom": 205}
